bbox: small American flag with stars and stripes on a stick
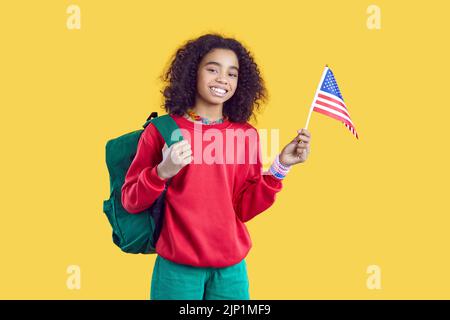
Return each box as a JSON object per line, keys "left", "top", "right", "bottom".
{"left": 308, "top": 66, "right": 359, "bottom": 139}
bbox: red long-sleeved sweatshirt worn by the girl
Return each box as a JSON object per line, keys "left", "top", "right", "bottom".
{"left": 122, "top": 115, "right": 282, "bottom": 268}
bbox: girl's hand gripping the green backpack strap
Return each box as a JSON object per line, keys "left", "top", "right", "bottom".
{"left": 156, "top": 140, "right": 193, "bottom": 179}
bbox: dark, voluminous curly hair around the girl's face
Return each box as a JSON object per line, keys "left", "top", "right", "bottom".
{"left": 160, "top": 33, "right": 268, "bottom": 123}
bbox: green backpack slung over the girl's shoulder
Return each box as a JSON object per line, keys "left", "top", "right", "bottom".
{"left": 103, "top": 112, "right": 183, "bottom": 253}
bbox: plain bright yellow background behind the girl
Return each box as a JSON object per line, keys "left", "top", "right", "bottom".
{"left": 0, "top": 0, "right": 450, "bottom": 299}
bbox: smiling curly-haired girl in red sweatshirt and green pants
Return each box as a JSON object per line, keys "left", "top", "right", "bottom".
{"left": 122, "top": 34, "right": 311, "bottom": 300}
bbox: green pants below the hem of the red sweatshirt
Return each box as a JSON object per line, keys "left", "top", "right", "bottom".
{"left": 150, "top": 255, "right": 250, "bottom": 300}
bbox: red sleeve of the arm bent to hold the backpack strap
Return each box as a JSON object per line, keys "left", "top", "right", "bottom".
{"left": 122, "top": 123, "right": 166, "bottom": 213}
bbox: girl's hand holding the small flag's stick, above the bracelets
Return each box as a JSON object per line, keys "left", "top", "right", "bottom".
{"left": 279, "top": 128, "right": 311, "bottom": 166}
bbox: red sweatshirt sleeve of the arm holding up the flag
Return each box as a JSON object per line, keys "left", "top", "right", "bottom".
{"left": 234, "top": 129, "right": 283, "bottom": 222}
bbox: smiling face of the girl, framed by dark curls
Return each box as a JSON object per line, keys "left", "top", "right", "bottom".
{"left": 197, "top": 49, "right": 239, "bottom": 105}
